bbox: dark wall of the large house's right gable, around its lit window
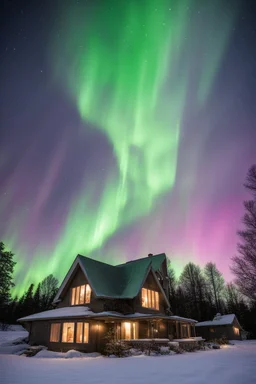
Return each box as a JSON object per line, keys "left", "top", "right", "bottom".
{"left": 133, "top": 272, "right": 167, "bottom": 314}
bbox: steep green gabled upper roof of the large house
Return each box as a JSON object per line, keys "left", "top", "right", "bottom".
{"left": 54, "top": 254, "right": 169, "bottom": 305}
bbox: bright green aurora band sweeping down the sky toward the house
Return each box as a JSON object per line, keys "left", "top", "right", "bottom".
{"left": 9, "top": 0, "right": 237, "bottom": 293}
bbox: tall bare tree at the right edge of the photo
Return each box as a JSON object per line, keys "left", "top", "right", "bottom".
{"left": 231, "top": 165, "right": 256, "bottom": 301}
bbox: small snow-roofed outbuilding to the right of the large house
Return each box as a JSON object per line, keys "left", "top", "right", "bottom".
{"left": 196, "top": 313, "right": 243, "bottom": 340}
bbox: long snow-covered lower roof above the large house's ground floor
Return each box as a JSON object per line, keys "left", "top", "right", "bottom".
{"left": 18, "top": 306, "right": 196, "bottom": 322}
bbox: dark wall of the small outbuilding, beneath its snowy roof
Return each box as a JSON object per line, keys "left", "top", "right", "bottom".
{"left": 196, "top": 325, "right": 241, "bottom": 340}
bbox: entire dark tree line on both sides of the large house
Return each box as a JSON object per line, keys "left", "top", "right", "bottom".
{"left": 0, "top": 165, "right": 256, "bottom": 338}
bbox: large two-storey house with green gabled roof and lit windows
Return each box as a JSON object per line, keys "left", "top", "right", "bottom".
{"left": 18, "top": 253, "right": 196, "bottom": 352}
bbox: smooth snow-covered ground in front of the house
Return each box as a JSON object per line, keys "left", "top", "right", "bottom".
{"left": 0, "top": 334, "right": 256, "bottom": 384}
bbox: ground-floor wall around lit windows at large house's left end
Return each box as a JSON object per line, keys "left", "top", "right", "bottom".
{"left": 29, "top": 319, "right": 107, "bottom": 352}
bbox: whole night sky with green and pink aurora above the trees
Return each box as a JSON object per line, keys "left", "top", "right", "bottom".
{"left": 0, "top": 0, "right": 256, "bottom": 293}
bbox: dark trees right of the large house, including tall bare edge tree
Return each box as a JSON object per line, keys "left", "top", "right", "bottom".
{"left": 168, "top": 165, "right": 256, "bottom": 338}
